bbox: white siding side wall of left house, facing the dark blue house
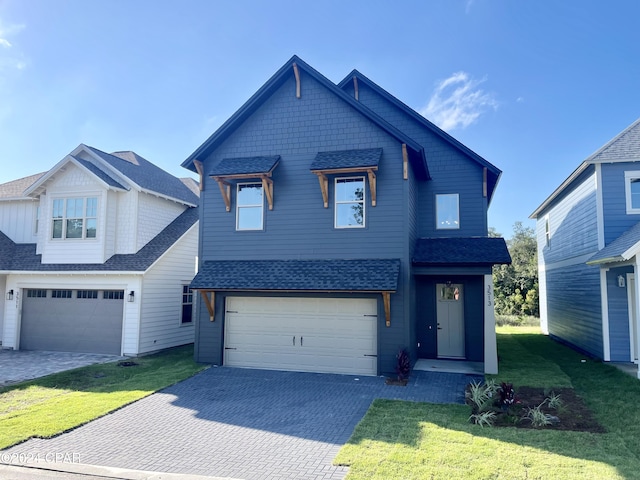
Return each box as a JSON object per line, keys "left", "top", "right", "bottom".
{"left": 138, "top": 222, "right": 198, "bottom": 353}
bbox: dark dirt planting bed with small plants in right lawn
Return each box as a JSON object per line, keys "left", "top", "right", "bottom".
{"left": 494, "top": 387, "right": 605, "bottom": 433}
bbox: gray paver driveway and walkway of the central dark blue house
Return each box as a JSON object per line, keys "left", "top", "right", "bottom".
{"left": 0, "top": 367, "right": 478, "bottom": 480}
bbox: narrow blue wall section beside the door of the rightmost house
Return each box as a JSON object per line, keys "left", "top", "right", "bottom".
{"left": 607, "top": 266, "right": 633, "bottom": 362}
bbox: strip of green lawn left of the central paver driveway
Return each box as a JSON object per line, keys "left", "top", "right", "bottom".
{"left": 0, "top": 346, "right": 205, "bottom": 449}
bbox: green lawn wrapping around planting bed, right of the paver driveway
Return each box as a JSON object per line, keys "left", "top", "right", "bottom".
{"left": 334, "top": 327, "right": 640, "bottom": 480}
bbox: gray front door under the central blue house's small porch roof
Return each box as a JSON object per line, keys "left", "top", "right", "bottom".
{"left": 436, "top": 283, "right": 465, "bottom": 358}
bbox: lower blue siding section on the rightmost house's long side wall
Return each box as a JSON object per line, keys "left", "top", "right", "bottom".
{"left": 546, "top": 263, "right": 603, "bottom": 358}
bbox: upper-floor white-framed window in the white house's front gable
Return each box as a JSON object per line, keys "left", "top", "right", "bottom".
{"left": 51, "top": 197, "right": 98, "bottom": 239}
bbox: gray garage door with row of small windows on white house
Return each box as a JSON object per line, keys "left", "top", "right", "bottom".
{"left": 20, "top": 289, "right": 124, "bottom": 355}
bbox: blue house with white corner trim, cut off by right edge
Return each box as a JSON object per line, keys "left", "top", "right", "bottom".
{"left": 531, "top": 119, "right": 640, "bottom": 378}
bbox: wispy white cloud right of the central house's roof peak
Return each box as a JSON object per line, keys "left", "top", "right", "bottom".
{"left": 420, "top": 72, "right": 498, "bottom": 130}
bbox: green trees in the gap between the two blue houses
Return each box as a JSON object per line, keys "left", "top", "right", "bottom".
{"left": 489, "top": 222, "right": 540, "bottom": 317}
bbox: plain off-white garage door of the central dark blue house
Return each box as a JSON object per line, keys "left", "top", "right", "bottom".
{"left": 224, "top": 297, "right": 377, "bottom": 375}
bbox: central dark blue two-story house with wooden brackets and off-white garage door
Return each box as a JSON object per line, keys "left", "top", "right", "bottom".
{"left": 182, "top": 56, "right": 510, "bottom": 375}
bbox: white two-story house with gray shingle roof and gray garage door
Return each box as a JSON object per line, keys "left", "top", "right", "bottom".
{"left": 0, "top": 144, "right": 199, "bottom": 355}
